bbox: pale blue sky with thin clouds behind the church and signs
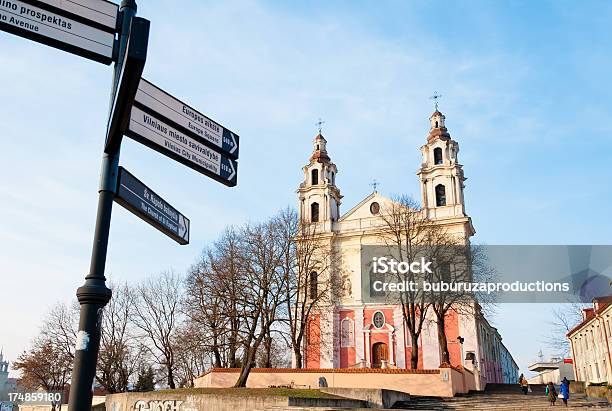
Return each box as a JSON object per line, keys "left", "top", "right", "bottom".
{"left": 0, "top": 1, "right": 612, "bottom": 380}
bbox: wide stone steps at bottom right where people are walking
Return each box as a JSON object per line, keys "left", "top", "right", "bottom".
{"left": 394, "top": 384, "right": 612, "bottom": 411}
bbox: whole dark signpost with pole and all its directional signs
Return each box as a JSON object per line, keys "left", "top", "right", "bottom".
{"left": 0, "top": 0, "right": 240, "bottom": 411}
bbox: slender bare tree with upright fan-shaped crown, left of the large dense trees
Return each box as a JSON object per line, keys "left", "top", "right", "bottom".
{"left": 132, "top": 272, "right": 182, "bottom": 389}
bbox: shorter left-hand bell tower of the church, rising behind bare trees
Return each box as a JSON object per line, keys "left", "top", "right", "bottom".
{"left": 297, "top": 132, "right": 342, "bottom": 227}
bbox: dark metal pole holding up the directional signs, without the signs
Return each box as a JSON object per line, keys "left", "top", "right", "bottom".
{"left": 68, "top": 0, "right": 136, "bottom": 411}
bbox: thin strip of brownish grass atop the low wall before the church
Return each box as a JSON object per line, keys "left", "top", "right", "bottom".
{"left": 155, "top": 388, "right": 341, "bottom": 398}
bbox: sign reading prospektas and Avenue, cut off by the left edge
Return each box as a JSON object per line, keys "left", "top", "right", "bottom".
{"left": 0, "top": 0, "right": 117, "bottom": 64}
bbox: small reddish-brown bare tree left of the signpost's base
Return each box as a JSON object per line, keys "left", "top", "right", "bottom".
{"left": 13, "top": 334, "right": 72, "bottom": 410}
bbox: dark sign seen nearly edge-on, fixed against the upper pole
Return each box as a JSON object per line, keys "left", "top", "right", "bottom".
{"left": 104, "top": 17, "right": 150, "bottom": 153}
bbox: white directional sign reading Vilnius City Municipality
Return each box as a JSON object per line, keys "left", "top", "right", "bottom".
{"left": 126, "top": 106, "right": 238, "bottom": 187}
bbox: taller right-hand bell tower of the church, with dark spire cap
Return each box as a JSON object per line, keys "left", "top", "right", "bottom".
{"left": 417, "top": 109, "right": 466, "bottom": 218}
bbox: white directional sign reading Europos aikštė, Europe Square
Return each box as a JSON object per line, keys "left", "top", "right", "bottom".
{"left": 135, "top": 79, "right": 239, "bottom": 159}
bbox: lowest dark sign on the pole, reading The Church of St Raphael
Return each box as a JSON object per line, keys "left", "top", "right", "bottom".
{"left": 115, "top": 167, "right": 189, "bottom": 245}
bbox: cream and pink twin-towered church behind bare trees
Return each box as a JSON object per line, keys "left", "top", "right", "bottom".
{"left": 297, "top": 105, "right": 518, "bottom": 386}
